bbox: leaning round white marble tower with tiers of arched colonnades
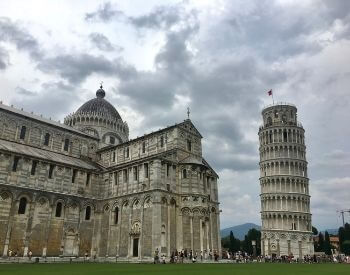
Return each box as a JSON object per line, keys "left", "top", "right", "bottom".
{"left": 259, "top": 103, "right": 314, "bottom": 258}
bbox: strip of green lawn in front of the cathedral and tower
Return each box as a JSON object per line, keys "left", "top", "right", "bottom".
{"left": 0, "top": 263, "right": 350, "bottom": 275}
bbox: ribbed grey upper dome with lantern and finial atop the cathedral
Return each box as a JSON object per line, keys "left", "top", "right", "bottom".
{"left": 76, "top": 85, "right": 121, "bottom": 120}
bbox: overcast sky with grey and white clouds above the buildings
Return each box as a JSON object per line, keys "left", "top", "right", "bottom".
{"left": 0, "top": 0, "right": 350, "bottom": 229}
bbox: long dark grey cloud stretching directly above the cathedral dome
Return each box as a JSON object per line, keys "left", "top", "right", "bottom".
{"left": 38, "top": 54, "right": 137, "bottom": 84}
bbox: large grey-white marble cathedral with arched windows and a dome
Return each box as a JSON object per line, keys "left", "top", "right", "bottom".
{"left": 0, "top": 86, "right": 221, "bottom": 259}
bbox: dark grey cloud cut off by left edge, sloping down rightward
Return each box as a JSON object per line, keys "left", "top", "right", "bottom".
{"left": 0, "top": 17, "right": 42, "bottom": 60}
